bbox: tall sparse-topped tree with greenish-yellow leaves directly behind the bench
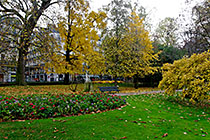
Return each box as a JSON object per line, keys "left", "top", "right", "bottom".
{"left": 102, "top": 0, "right": 132, "bottom": 84}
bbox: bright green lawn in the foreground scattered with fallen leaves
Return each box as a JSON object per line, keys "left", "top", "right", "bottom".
{"left": 0, "top": 95, "right": 210, "bottom": 140}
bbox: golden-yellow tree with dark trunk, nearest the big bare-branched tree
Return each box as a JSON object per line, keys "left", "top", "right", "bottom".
{"left": 46, "top": 0, "right": 106, "bottom": 84}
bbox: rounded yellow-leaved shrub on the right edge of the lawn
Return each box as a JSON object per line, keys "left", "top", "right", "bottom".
{"left": 159, "top": 51, "right": 210, "bottom": 102}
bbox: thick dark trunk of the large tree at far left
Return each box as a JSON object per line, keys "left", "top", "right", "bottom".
{"left": 16, "top": 48, "right": 26, "bottom": 86}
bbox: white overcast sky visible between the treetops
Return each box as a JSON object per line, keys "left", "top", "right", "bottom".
{"left": 90, "top": 0, "right": 202, "bottom": 28}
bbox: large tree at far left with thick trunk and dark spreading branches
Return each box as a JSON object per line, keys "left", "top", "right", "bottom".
{"left": 0, "top": 0, "right": 61, "bottom": 85}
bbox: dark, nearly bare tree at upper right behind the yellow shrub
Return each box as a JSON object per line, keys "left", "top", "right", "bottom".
{"left": 183, "top": 0, "right": 210, "bottom": 55}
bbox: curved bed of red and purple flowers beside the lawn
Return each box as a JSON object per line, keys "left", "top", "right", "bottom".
{"left": 0, "top": 93, "right": 126, "bottom": 121}
